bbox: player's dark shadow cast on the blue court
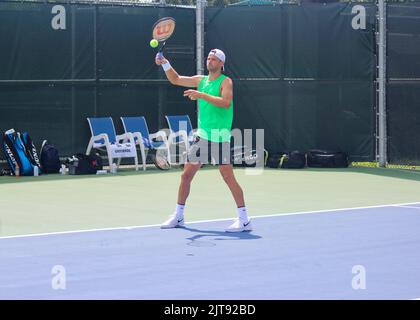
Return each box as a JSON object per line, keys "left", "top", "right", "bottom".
{"left": 183, "top": 227, "right": 262, "bottom": 247}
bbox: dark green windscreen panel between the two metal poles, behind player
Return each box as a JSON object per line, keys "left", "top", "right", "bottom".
{"left": 205, "top": 3, "right": 376, "bottom": 161}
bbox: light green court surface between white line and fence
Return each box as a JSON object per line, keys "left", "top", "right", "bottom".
{"left": 0, "top": 167, "right": 420, "bottom": 237}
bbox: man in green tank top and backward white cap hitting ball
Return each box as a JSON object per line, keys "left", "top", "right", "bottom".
{"left": 155, "top": 49, "right": 252, "bottom": 232}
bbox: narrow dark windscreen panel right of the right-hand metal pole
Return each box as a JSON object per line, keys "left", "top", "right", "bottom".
{"left": 387, "top": 2, "right": 420, "bottom": 165}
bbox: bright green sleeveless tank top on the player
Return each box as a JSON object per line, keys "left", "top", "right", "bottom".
{"left": 197, "top": 74, "right": 233, "bottom": 142}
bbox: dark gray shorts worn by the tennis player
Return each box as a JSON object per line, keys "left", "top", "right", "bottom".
{"left": 187, "top": 137, "right": 232, "bottom": 165}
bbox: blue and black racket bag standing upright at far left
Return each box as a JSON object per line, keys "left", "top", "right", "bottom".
{"left": 2, "top": 129, "right": 41, "bottom": 176}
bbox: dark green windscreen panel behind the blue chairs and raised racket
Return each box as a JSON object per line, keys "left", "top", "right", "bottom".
{"left": 0, "top": 2, "right": 196, "bottom": 156}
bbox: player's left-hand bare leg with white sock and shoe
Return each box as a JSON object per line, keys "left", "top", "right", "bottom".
{"left": 161, "top": 162, "right": 201, "bottom": 229}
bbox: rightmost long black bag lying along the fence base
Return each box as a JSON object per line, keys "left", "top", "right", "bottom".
{"left": 307, "top": 150, "right": 349, "bottom": 168}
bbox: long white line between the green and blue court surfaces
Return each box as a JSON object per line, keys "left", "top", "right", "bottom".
{"left": 0, "top": 202, "right": 420, "bottom": 240}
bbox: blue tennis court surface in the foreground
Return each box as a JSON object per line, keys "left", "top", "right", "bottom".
{"left": 0, "top": 203, "right": 420, "bottom": 300}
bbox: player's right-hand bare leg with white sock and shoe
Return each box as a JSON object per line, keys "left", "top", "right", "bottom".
{"left": 219, "top": 164, "right": 252, "bottom": 232}
